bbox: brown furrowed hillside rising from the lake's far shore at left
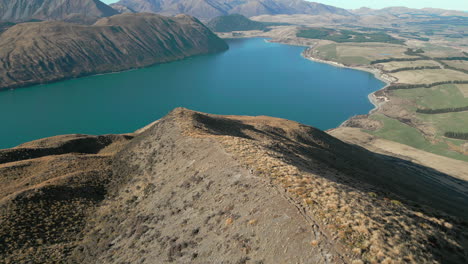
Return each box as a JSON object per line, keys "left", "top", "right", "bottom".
{"left": 0, "top": 14, "right": 228, "bottom": 89}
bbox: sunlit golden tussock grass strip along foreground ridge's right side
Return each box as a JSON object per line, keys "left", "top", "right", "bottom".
{"left": 177, "top": 112, "right": 463, "bottom": 263}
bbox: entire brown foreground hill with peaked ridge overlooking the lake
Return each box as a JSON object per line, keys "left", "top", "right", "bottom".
{"left": 0, "top": 109, "right": 468, "bottom": 263}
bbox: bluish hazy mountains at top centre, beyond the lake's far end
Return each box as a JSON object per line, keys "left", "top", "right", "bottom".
{"left": 114, "top": 0, "right": 353, "bottom": 19}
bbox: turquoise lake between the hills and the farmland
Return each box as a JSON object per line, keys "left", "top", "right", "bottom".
{"left": 0, "top": 39, "right": 384, "bottom": 148}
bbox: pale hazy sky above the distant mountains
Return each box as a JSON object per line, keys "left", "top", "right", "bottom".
{"left": 103, "top": 0, "right": 468, "bottom": 11}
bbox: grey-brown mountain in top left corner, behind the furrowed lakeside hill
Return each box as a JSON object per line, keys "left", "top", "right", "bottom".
{"left": 0, "top": 0, "right": 118, "bottom": 23}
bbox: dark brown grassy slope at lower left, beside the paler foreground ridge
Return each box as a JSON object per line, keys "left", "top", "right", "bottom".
{"left": 0, "top": 135, "right": 132, "bottom": 263}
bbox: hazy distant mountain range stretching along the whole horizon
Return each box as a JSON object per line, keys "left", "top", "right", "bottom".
{"left": 0, "top": 0, "right": 468, "bottom": 24}
